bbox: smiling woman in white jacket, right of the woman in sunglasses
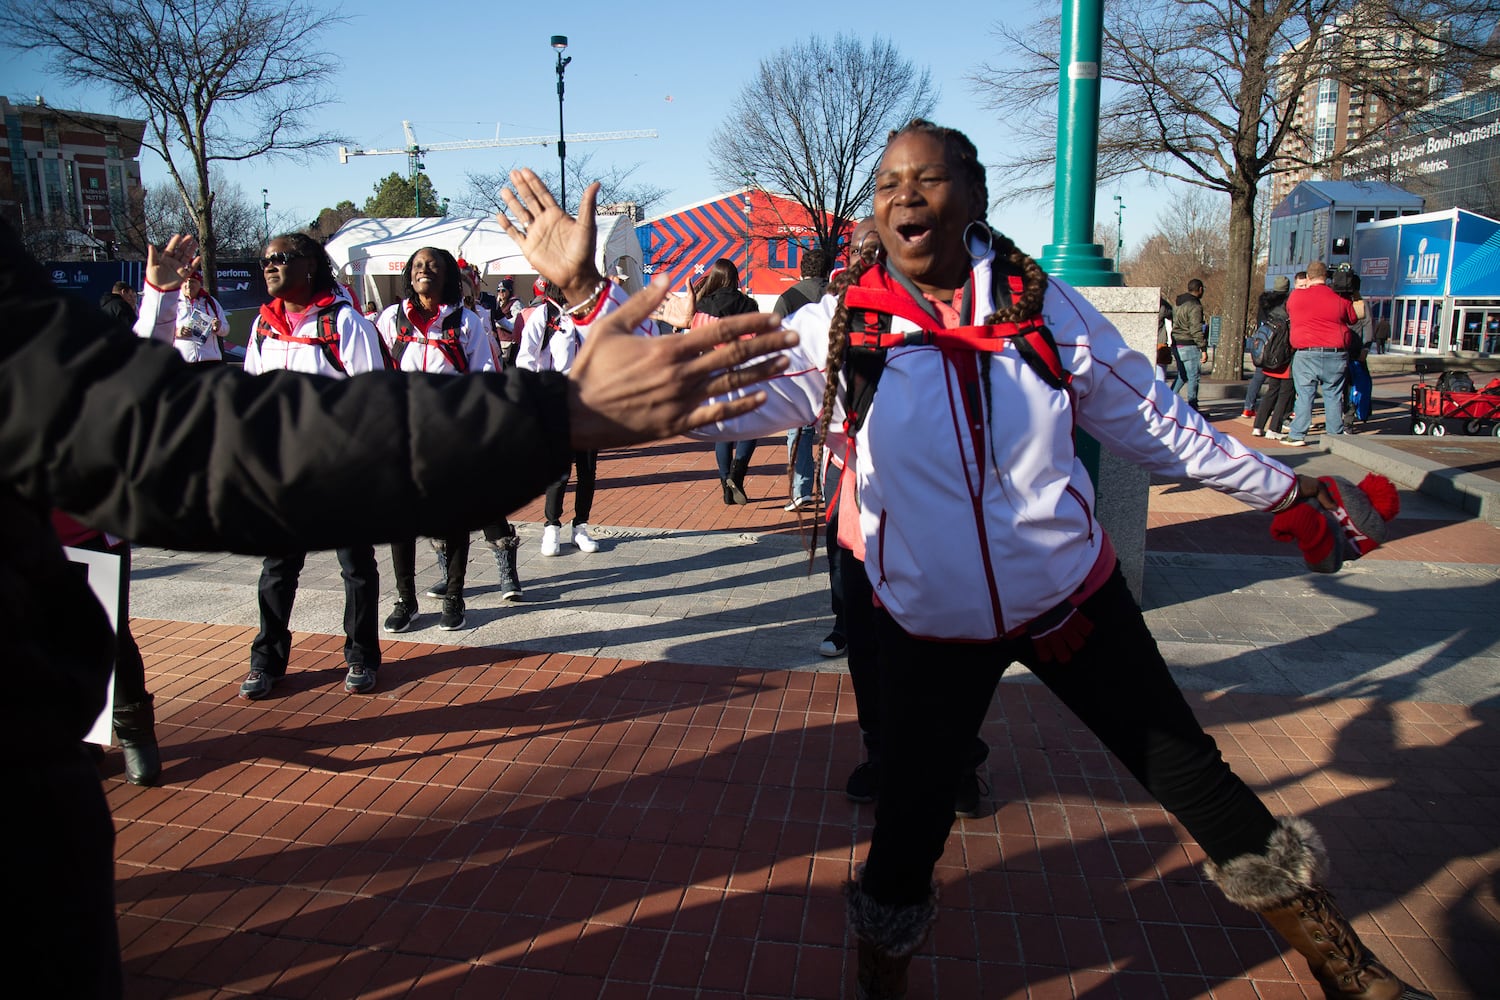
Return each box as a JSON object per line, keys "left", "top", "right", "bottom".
{"left": 375, "top": 246, "right": 495, "bottom": 633}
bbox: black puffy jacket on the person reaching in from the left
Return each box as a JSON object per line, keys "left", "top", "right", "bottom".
{"left": 0, "top": 223, "right": 573, "bottom": 759}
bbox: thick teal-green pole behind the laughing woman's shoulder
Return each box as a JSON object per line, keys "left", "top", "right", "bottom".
{"left": 1041, "top": 0, "right": 1125, "bottom": 286}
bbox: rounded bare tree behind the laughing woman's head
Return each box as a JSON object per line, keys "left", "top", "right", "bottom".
{"left": 708, "top": 34, "right": 938, "bottom": 259}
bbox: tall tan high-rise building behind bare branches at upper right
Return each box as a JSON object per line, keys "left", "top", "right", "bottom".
{"left": 1271, "top": 4, "right": 1448, "bottom": 204}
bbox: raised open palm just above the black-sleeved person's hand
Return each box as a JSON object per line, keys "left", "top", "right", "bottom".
{"left": 495, "top": 168, "right": 605, "bottom": 306}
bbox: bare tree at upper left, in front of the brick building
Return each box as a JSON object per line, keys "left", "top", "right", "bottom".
{"left": 0, "top": 0, "right": 342, "bottom": 293}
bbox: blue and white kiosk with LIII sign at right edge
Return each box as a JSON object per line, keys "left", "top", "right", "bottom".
{"left": 1353, "top": 208, "right": 1500, "bottom": 354}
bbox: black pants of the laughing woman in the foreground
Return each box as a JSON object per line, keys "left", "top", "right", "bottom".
{"left": 863, "top": 567, "right": 1277, "bottom": 906}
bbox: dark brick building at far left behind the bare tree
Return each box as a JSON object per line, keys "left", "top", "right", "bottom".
{"left": 0, "top": 97, "right": 146, "bottom": 258}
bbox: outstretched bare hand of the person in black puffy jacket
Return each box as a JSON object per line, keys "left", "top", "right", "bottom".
{"left": 569, "top": 282, "right": 797, "bottom": 451}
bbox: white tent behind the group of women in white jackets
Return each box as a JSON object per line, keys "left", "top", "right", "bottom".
{"left": 327, "top": 214, "right": 641, "bottom": 306}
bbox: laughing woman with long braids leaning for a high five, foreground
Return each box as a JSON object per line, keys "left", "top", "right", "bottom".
{"left": 503, "top": 120, "right": 1428, "bottom": 1000}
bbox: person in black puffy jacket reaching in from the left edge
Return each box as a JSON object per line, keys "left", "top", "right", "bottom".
{"left": 0, "top": 223, "right": 795, "bottom": 999}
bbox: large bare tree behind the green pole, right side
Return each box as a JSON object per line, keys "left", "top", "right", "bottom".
{"left": 974, "top": 0, "right": 1494, "bottom": 378}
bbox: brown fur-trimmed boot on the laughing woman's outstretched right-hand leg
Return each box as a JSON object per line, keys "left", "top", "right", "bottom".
{"left": 1203, "top": 819, "right": 1433, "bottom": 1000}
